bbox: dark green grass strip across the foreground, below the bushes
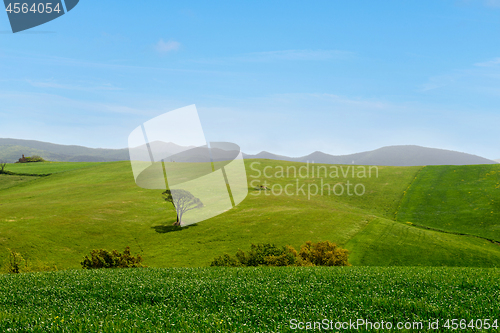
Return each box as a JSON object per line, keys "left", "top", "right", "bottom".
{"left": 0, "top": 267, "right": 500, "bottom": 333}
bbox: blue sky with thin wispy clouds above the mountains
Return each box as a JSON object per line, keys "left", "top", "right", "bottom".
{"left": 0, "top": 0, "right": 500, "bottom": 159}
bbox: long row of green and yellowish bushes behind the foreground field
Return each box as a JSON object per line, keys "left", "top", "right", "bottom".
{"left": 210, "top": 241, "right": 350, "bottom": 267}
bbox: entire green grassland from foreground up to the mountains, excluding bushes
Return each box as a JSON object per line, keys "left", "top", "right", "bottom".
{"left": 0, "top": 160, "right": 500, "bottom": 332}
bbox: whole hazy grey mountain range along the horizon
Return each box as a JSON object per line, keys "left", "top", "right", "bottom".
{"left": 0, "top": 138, "right": 500, "bottom": 166}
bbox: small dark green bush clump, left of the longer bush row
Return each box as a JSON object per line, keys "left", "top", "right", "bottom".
{"left": 81, "top": 246, "right": 146, "bottom": 269}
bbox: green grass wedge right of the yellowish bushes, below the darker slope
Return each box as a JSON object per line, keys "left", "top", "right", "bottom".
{"left": 346, "top": 219, "right": 500, "bottom": 267}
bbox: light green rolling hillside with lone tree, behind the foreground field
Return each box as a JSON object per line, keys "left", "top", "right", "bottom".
{"left": 0, "top": 160, "right": 500, "bottom": 269}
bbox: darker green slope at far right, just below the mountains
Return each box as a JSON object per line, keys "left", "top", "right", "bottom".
{"left": 397, "top": 165, "right": 500, "bottom": 241}
